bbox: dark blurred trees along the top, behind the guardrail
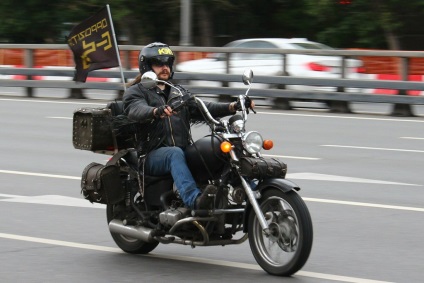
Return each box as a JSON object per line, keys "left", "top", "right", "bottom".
{"left": 0, "top": 0, "right": 424, "bottom": 50}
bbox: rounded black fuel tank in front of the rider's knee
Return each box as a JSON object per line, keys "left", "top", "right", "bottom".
{"left": 185, "top": 135, "right": 228, "bottom": 183}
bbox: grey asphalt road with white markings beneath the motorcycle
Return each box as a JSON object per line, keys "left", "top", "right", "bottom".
{"left": 0, "top": 93, "right": 424, "bottom": 283}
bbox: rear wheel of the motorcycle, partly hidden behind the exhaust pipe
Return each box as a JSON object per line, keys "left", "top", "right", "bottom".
{"left": 106, "top": 204, "right": 159, "bottom": 254}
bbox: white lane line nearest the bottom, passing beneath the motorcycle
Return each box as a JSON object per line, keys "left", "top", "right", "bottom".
{"left": 0, "top": 233, "right": 389, "bottom": 283}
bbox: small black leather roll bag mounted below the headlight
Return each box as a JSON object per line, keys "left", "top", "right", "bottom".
{"left": 240, "top": 157, "right": 287, "bottom": 180}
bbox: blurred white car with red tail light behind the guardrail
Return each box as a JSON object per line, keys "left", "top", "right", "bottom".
{"left": 176, "top": 38, "right": 364, "bottom": 90}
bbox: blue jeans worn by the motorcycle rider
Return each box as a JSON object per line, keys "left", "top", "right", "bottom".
{"left": 144, "top": 147, "right": 201, "bottom": 208}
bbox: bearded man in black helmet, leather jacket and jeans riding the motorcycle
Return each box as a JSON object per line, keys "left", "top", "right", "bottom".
{"left": 123, "top": 42, "right": 255, "bottom": 209}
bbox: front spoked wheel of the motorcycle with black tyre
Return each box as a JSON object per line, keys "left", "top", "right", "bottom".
{"left": 248, "top": 189, "right": 313, "bottom": 276}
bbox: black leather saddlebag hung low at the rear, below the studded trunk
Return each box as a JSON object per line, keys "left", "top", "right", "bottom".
{"left": 81, "top": 150, "right": 127, "bottom": 204}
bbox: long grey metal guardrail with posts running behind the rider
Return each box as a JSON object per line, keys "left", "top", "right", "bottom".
{"left": 0, "top": 44, "right": 424, "bottom": 116}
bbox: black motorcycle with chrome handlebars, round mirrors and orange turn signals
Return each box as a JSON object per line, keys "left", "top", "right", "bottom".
{"left": 77, "top": 70, "right": 313, "bottom": 276}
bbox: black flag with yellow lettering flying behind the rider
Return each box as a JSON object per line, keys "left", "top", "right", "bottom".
{"left": 67, "top": 6, "right": 119, "bottom": 82}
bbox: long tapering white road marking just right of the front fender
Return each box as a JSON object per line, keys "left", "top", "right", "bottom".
{"left": 286, "top": 173, "right": 423, "bottom": 187}
